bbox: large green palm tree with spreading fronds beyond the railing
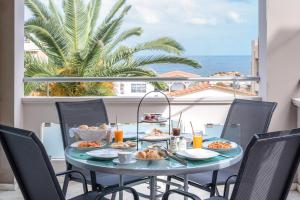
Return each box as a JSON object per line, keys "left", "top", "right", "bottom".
{"left": 25, "top": 0, "right": 200, "bottom": 96}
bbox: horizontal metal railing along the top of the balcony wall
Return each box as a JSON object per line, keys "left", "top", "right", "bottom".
{"left": 23, "top": 76, "right": 260, "bottom": 96}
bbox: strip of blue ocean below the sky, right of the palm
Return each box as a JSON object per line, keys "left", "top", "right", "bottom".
{"left": 150, "top": 55, "right": 251, "bottom": 76}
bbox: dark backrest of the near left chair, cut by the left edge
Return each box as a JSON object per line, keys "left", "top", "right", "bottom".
{"left": 0, "top": 125, "right": 65, "bottom": 200}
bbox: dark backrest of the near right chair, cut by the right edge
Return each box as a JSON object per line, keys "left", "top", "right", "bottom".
{"left": 231, "top": 129, "right": 300, "bottom": 200}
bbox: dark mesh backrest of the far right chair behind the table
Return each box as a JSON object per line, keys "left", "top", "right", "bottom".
{"left": 221, "top": 99, "right": 277, "bottom": 150}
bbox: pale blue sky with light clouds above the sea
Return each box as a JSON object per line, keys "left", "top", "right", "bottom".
{"left": 25, "top": 0, "right": 258, "bottom": 56}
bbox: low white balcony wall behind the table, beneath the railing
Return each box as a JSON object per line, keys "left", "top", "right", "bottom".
{"left": 23, "top": 97, "right": 231, "bottom": 138}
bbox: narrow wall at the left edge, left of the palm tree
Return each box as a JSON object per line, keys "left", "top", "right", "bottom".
{"left": 0, "top": 0, "right": 24, "bottom": 186}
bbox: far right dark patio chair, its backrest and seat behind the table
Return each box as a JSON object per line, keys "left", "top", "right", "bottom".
{"left": 166, "top": 99, "right": 277, "bottom": 196}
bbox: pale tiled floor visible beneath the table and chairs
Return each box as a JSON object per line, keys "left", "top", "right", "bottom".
{"left": 0, "top": 178, "right": 300, "bottom": 200}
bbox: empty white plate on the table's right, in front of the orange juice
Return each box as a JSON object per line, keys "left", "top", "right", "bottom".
{"left": 176, "top": 149, "right": 220, "bottom": 160}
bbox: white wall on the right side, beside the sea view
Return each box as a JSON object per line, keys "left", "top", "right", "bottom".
{"left": 259, "top": 0, "right": 300, "bottom": 131}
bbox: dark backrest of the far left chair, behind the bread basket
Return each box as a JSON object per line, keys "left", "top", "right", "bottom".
{"left": 56, "top": 99, "right": 108, "bottom": 148}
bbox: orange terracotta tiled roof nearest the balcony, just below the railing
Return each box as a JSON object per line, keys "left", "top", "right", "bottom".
{"left": 167, "top": 82, "right": 255, "bottom": 97}
